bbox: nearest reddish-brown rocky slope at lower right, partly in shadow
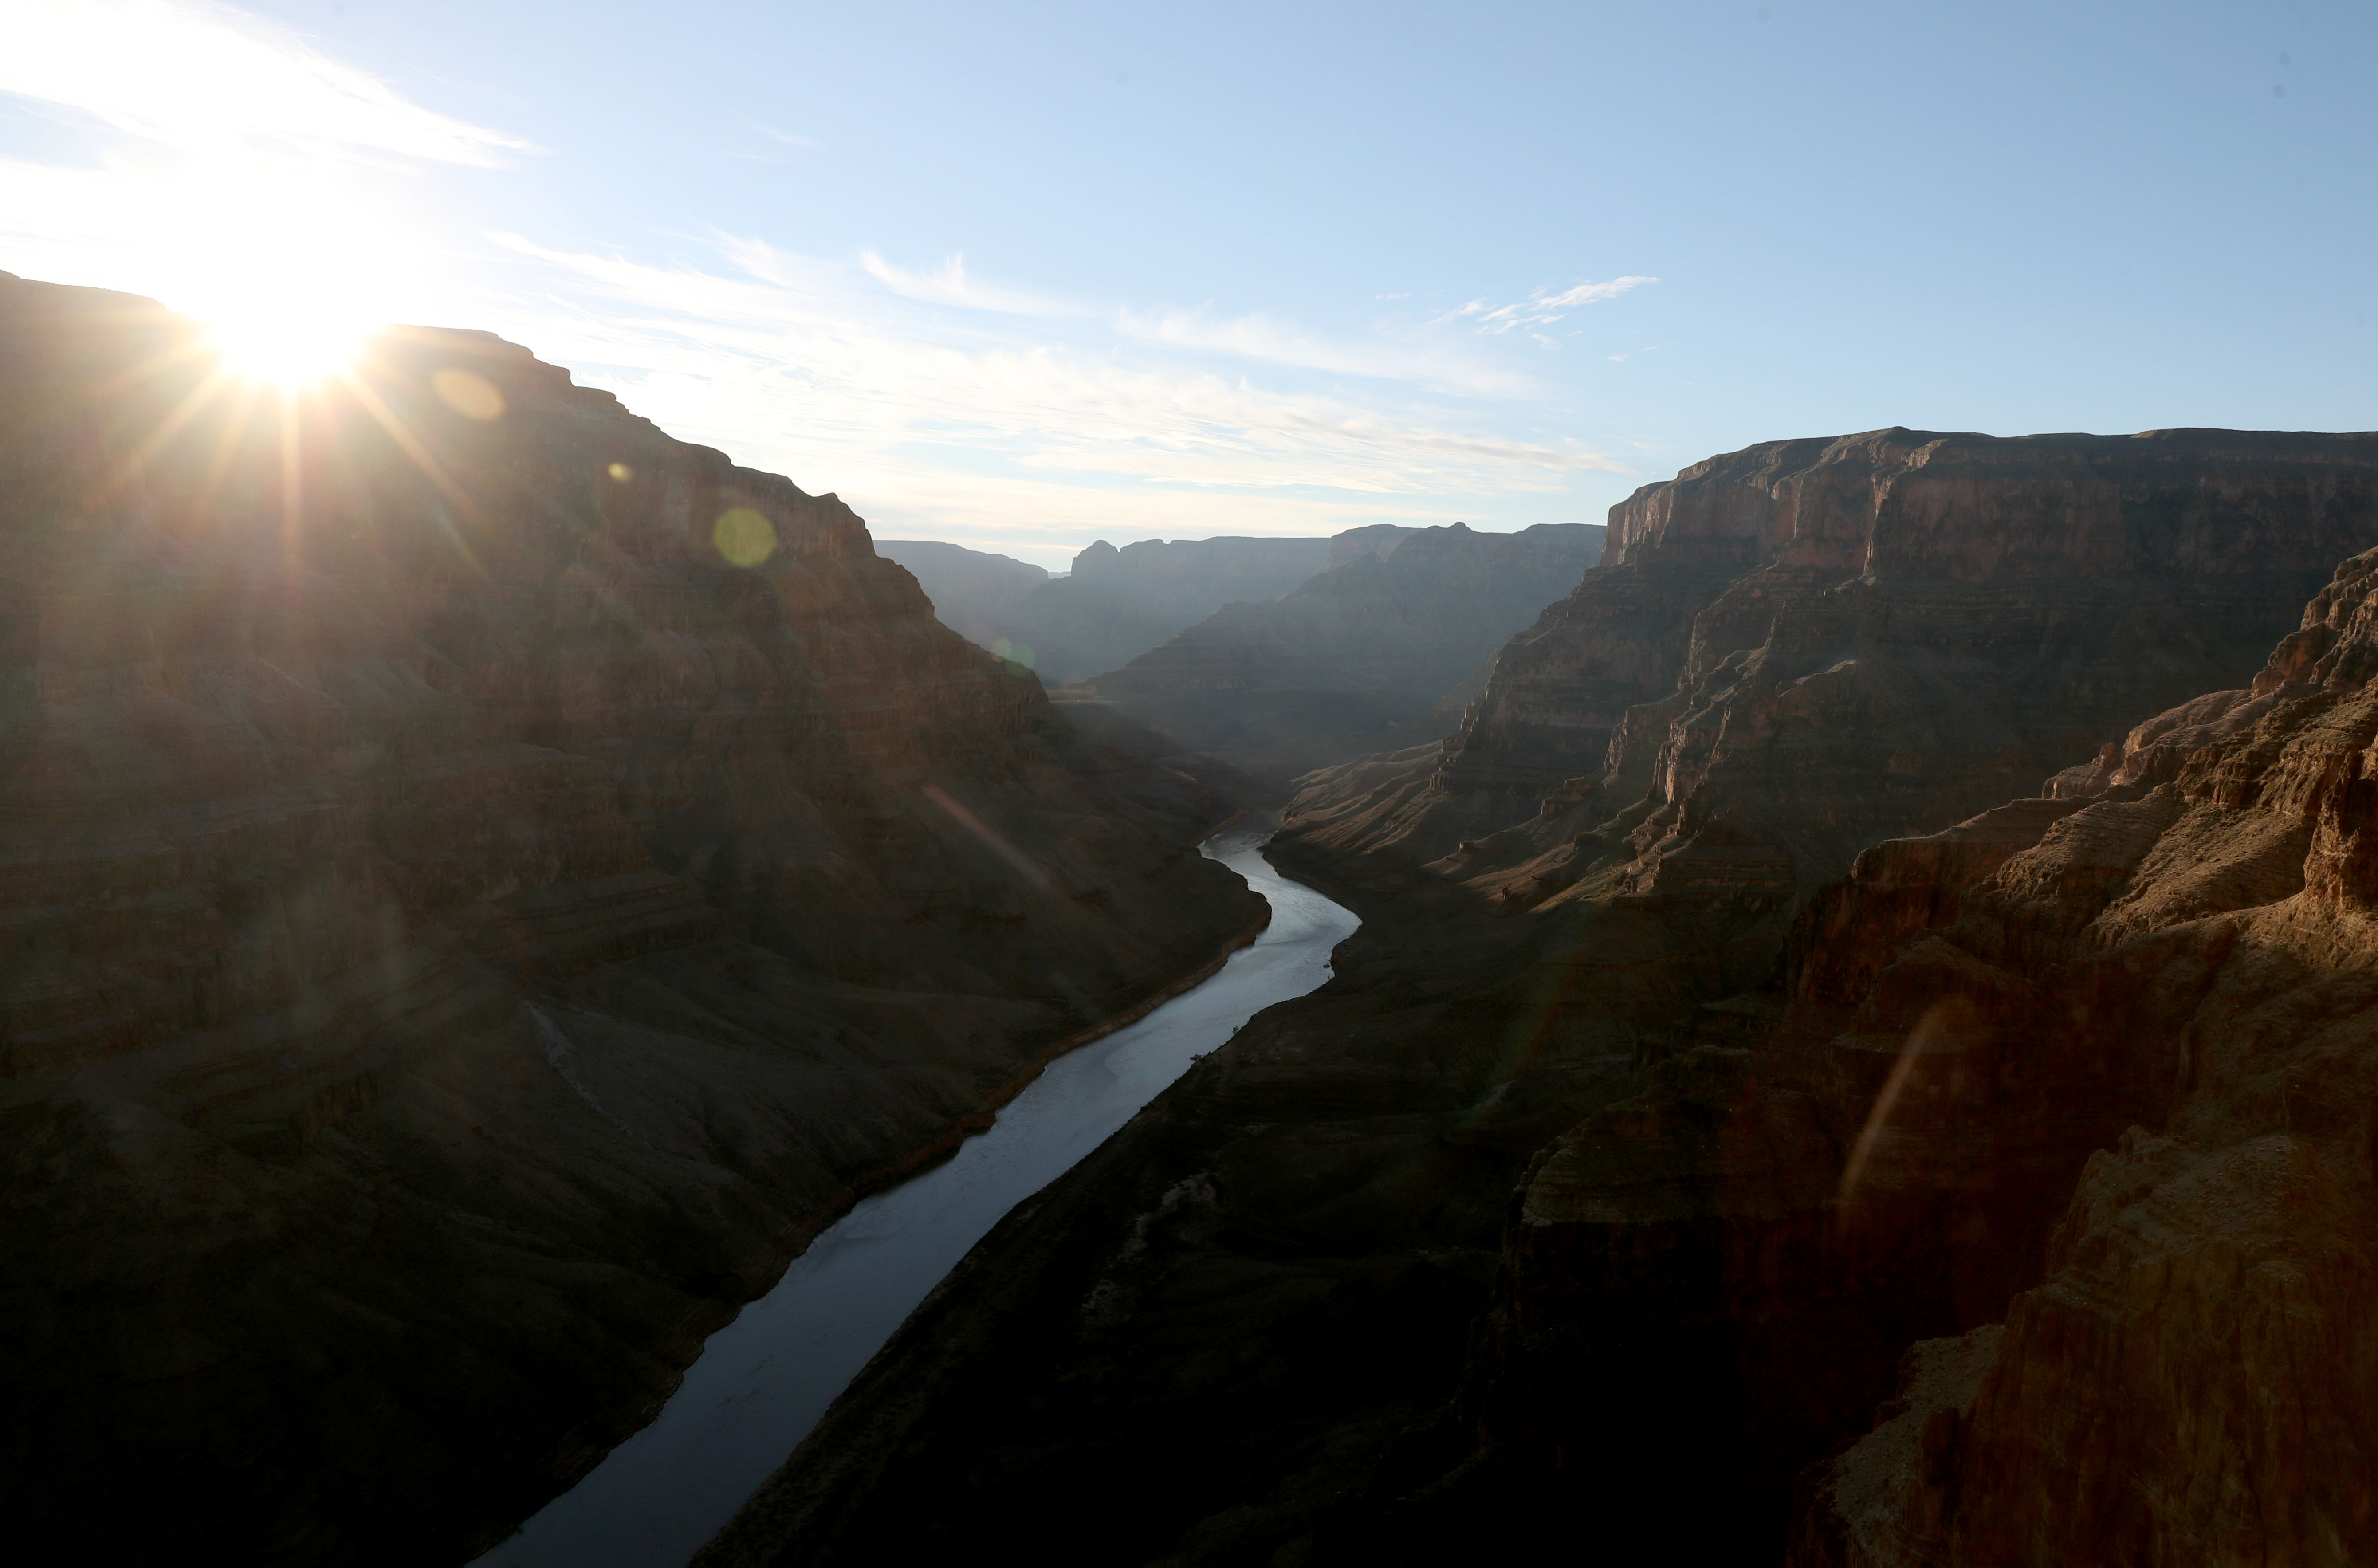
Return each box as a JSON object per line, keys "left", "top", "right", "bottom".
{"left": 1436, "top": 554, "right": 2378, "bottom": 1568}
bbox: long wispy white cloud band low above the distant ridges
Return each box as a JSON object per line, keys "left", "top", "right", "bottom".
{"left": 485, "top": 238, "right": 1622, "bottom": 523}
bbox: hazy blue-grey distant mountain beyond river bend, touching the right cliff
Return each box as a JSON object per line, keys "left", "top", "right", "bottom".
{"left": 1063, "top": 523, "right": 1603, "bottom": 797}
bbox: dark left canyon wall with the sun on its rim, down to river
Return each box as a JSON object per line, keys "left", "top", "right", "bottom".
{"left": 0, "top": 276, "right": 1260, "bottom": 1563}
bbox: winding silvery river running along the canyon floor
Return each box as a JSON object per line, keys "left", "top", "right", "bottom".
{"left": 473, "top": 828, "right": 1358, "bottom": 1568}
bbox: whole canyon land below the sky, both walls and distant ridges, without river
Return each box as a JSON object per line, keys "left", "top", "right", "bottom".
{"left": 0, "top": 260, "right": 2378, "bottom": 1568}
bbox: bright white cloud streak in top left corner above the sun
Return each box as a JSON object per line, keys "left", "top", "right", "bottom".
{"left": 0, "top": 0, "right": 533, "bottom": 164}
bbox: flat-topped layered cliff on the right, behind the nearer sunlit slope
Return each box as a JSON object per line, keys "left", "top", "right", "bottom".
{"left": 1289, "top": 431, "right": 2378, "bottom": 885}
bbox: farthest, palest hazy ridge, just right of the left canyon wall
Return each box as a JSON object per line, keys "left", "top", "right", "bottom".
{"left": 992, "top": 523, "right": 1405, "bottom": 685}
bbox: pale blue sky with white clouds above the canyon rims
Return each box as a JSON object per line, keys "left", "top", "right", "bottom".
{"left": 0, "top": 0, "right": 2378, "bottom": 566}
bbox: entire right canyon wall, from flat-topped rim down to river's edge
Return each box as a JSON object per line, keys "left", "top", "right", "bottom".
{"left": 697, "top": 431, "right": 2378, "bottom": 1568}
